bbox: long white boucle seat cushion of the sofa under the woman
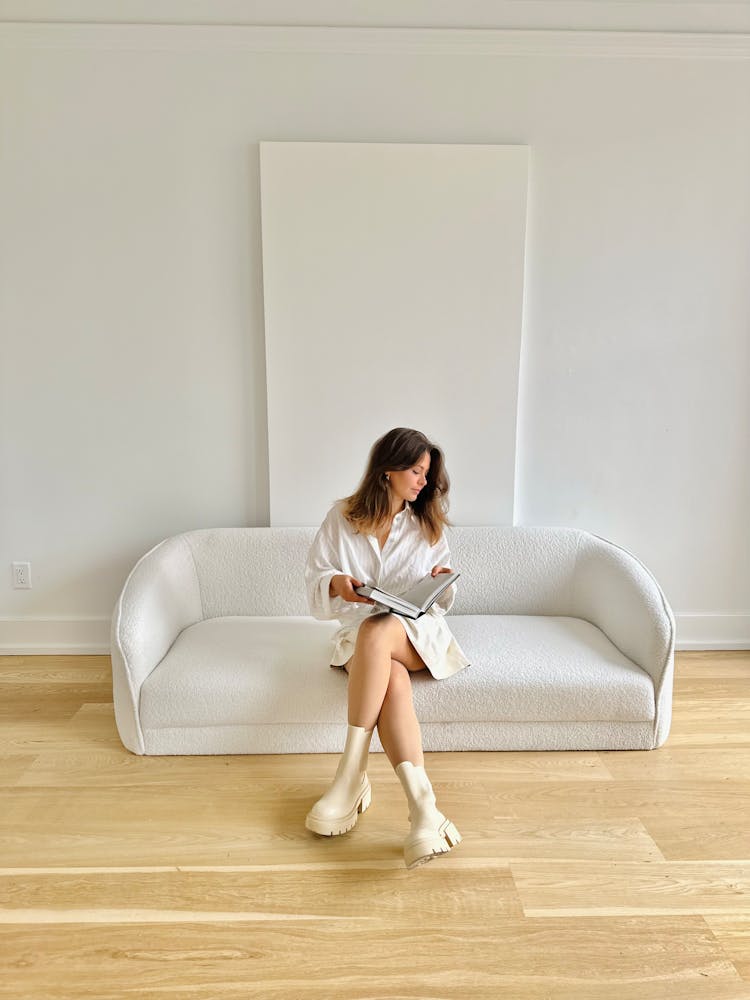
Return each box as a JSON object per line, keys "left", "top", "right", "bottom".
{"left": 140, "top": 615, "right": 654, "bottom": 730}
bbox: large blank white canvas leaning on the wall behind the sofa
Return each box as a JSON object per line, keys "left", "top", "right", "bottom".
{"left": 260, "top": 142, "right": 528, "bottom": 526}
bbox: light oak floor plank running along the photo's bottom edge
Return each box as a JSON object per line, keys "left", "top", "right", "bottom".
{"left": 0, "top": 920, "right": 747, "bottom": 1000}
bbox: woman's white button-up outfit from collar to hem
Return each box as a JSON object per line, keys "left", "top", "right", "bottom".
{"left": 305, "top": 500, "right": 469, "bottom": 678}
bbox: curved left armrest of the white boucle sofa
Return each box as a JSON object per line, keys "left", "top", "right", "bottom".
{"left": 110, "top": 535, "right": 203, "bottom": 754}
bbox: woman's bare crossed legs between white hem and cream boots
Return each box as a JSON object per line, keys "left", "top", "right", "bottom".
{"left": 344, "top": 614, "right": 426, "bottom": 768}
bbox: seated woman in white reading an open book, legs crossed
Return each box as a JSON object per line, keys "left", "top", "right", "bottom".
{"left": 305, "top": 427, "right": 469, "bottom": 868}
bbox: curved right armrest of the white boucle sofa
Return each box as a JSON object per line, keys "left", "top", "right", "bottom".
{"left": 573, "top": 532, "right": 676, "bottom": 746}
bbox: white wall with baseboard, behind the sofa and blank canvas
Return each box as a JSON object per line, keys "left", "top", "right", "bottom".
{"left": 0, "top": 3, "right": 750, "bottom": 652}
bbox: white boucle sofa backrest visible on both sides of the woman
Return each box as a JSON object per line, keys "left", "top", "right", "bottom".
{"left": 181, "top": 526, "right": 586, "bottom": 618}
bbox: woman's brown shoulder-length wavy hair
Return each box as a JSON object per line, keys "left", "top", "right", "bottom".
{"left": 341, "top": 427, "right": 452, "bottom": 545}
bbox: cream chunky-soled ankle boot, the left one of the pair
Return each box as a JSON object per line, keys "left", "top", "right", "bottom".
{"left": 305, "top": 725, "right": 374, "bottom": 837}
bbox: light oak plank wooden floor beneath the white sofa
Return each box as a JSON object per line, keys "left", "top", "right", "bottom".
{"left": 0, "top": 652, "right": 750, "bottom": 1000}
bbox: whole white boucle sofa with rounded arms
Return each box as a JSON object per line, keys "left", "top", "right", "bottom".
{"left": 111, "top": 527, "right": 675, "bottom": 754}
